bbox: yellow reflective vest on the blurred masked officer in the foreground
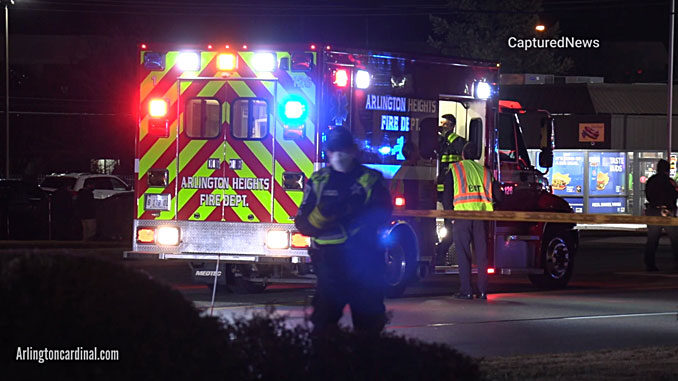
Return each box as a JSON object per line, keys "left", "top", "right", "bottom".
{"left": 308, "top": 169, "right": 381, "bottom": 245}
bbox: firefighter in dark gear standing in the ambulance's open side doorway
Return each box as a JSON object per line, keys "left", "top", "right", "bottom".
{"left": 436, "top": 114, "right": 466, "bottom": 265}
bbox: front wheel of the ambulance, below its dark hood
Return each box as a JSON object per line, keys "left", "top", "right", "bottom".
{"left": 529, "top": 232, "right": 575, "bottom": 289}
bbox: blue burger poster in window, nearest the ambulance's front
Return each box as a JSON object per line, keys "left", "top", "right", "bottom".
{"left": 549, "top": 151, "right": 585, "bottom": 196}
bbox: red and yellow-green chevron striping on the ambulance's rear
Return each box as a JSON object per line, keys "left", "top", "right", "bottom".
{"left": 135, "top": 51, "right": 318, "bottom": 223}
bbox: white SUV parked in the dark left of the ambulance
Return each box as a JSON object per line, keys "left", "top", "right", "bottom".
{"left": 40, "top": 173, "right": 132, "bottom": 200}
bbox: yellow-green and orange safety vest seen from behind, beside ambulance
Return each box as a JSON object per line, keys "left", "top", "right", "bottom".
{"left": 451, "top": 160, "right": 494, "bottom": 212}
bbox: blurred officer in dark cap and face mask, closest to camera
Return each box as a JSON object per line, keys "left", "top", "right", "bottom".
{"left": 294, "top": 127, "right": 392, "bottom": 335}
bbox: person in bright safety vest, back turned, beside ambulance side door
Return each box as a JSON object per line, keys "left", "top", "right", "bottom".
{"left": 443, "top": 143, "right": 502, "bottom": 299}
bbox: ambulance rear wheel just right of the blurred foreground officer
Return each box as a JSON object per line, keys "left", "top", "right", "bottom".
{"left": 385, "top": 229, "right": 419, "bottom": 298}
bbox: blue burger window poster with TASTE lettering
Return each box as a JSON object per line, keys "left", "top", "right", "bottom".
{"left": 589, "top": 152, "right": 626, "bottom": 196}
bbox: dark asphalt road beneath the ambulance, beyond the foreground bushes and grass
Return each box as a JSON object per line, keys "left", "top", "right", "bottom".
{"left": 2, "top": 230, "right": 678, "bottom": 357}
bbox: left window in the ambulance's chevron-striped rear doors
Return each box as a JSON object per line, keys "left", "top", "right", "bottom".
{"left": 184, "top": 99, "right": 221, "bottom": 139}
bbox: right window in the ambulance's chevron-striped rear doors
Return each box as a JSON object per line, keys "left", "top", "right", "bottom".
{"left": 231, "top": 99, "right": 269, "bottom": 139}
